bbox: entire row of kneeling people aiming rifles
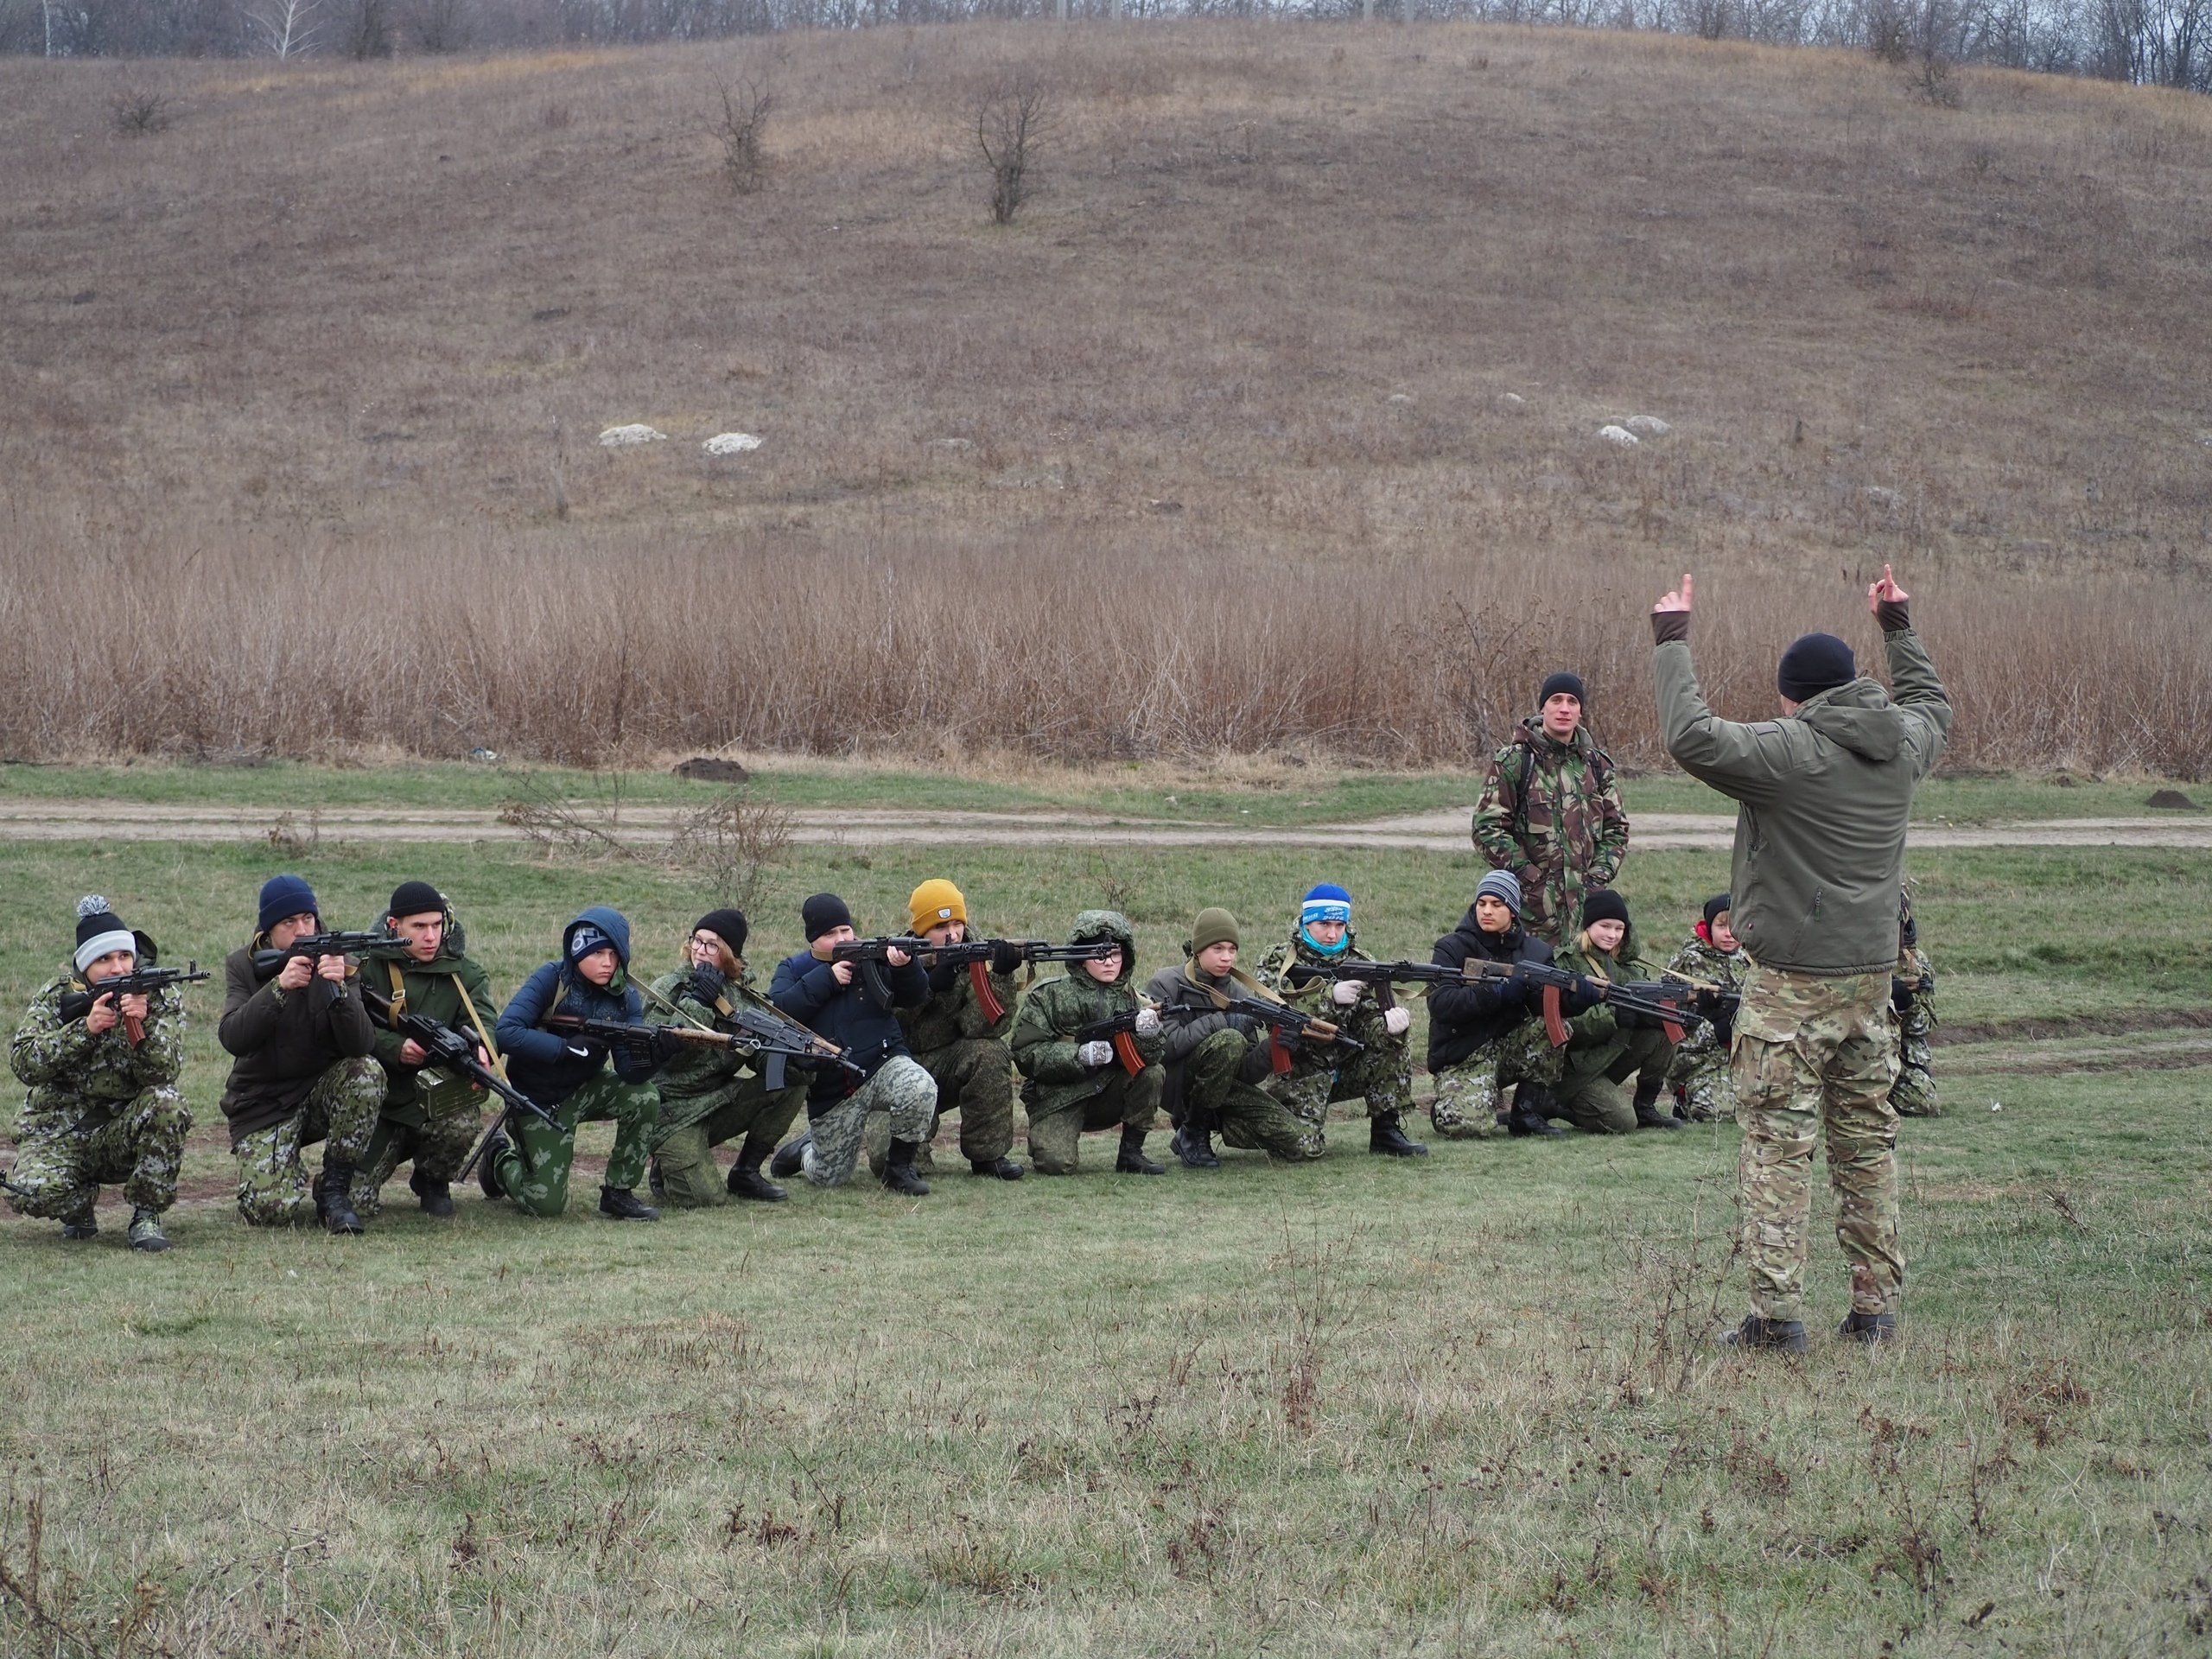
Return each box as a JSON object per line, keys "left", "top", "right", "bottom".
{"left": 4, "top": 872, "right": 1933, "bottom": 1249}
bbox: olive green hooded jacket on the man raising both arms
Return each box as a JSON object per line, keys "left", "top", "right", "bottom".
{"left": 1652, "top": 626, "right": 1951, "bottom": 976}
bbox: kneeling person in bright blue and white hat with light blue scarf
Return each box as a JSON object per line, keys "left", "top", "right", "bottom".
{"left": 1255, "top": 882, "right": 1429, "bottom": 1157}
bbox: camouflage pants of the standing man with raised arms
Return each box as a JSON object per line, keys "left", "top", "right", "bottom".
{"left": 1737, "top": 967, "right": 1904, "bottom": 1319}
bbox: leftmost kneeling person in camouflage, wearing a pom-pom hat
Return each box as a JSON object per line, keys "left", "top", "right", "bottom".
{"left": 9, "top": 896, "right": 193, "bottom": 1249}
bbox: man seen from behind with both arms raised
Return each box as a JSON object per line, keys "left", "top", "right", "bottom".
{"left": 1652, "top": 564, "right": 1951, "bottom": 1351}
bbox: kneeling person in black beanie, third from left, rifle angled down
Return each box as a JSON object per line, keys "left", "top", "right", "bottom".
{"left": 354, "top": 880, "right": 500, "bottom": 1219}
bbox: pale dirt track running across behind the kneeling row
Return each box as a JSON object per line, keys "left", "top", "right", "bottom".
{"left": 0, "top": 801, "right": 2212, "bottom": 852}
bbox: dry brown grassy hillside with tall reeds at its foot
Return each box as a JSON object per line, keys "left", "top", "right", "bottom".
{"left": 0, "top": 24, "right": 2212, "bottom": 777}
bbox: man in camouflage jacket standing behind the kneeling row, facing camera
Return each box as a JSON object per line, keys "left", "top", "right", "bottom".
{"left": 1473, "top": 671, "right": 1628, "bottom": 944}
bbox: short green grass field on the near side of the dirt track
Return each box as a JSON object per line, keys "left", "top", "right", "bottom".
{"left": 0, "top": 809, "right": 2212, "bottom": 1656}
